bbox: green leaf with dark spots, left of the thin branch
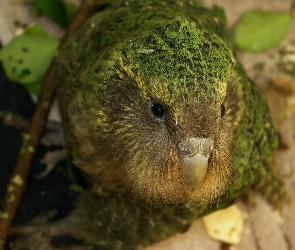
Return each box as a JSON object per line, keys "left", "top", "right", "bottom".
{"left": 0, "top": 27, "right": 59, "bottom": 93}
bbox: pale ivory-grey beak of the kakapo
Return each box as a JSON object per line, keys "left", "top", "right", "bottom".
{"left": 178, "top": 137, "right": 214, "bottom": 192}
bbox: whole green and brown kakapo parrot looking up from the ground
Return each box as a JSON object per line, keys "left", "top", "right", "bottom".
{"left": 55, "top": 0, "right": 282, "bottom": 249}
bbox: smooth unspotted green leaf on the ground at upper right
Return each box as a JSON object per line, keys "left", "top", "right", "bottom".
{"left": 234, "top": 10, "right": 292, "bottom": 52}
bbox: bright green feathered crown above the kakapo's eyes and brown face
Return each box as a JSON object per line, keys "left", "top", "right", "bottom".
{"left": 122, "top": 18, "right": 234, "bottom": 103}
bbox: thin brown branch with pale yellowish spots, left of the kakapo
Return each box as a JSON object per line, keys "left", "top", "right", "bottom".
{"left": 0, "top": 0, "right": 99, "bottom": 250}
